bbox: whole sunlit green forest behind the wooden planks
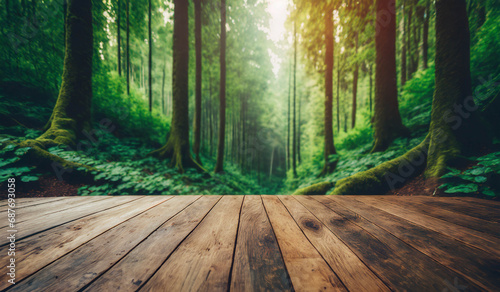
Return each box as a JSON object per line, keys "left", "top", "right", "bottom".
{"left": 0, "top": 0, "right": 500, "bottom": 199}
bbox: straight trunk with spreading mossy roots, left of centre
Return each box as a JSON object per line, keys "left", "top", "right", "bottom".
{"left": 151, "top": 0, "right": 202, "bottom": 172}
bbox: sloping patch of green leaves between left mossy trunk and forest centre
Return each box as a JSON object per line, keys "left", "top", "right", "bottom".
{"left": 44, "top": 133, "right": 270, "bottom": 196}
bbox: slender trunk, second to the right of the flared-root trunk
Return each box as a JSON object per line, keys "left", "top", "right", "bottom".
{"left": 214, "top": 0, "right": 226, "bottom": 173}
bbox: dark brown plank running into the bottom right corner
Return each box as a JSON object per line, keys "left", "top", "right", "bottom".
{"left": 332, "top": 196, "right": 500, "bottom": 291}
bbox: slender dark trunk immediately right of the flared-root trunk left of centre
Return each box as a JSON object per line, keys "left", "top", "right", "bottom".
{"left": 193, "top": 0, "right": 202, "bottom": 163}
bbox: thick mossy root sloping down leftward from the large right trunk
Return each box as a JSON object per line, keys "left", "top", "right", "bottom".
{"left": 330, "top": 136, "right": 429, "bottom": 195}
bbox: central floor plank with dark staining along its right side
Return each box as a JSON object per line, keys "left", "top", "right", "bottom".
{"left": 230, "top": 196, "right": 292, "bottom": 291}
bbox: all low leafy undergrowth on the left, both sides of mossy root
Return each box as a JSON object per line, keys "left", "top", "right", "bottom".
{"left": 0, "top": 126, "right": 272, "bottom": 196}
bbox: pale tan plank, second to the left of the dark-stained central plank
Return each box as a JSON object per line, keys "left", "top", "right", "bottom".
{"left": 85, "top": 196, "right": 220, "bottom": 291}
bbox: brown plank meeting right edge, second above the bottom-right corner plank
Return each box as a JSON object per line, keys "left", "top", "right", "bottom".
{"left": 376, "top": 196, "right": 500, "bottom": 238}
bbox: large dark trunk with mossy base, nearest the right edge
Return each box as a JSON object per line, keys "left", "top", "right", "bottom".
{"left": 425, "top": 0, "right": 486, "bottom": 177}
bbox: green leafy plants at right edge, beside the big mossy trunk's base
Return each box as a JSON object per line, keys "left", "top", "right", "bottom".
{"left": 440, "top": 152, "right": 500, "bottom": 197}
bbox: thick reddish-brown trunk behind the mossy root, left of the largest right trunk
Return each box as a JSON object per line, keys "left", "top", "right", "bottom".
{"left": 372, "top": 0, "right": 408, "bottom": 152}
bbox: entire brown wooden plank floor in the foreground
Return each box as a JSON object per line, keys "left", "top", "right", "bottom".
{"left": 0, "top": 196, "right": 500, "bottom": 291}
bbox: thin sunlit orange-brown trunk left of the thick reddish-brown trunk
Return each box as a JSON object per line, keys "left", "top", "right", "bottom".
{"left": 322, "top": 9, "right": 337, "bottom": 174}
